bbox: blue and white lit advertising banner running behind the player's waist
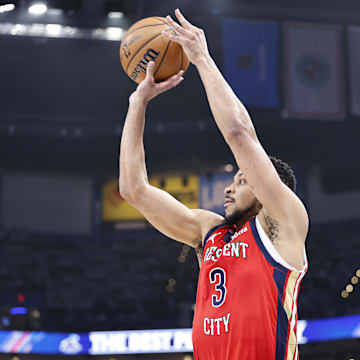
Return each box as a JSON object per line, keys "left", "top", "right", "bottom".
{"left": 0, "top": 315, "right": 360, "bottom": 355}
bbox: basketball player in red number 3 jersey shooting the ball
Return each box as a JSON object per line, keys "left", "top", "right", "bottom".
{"left": 119, "top": 10, "right": 308, "bottom": 360}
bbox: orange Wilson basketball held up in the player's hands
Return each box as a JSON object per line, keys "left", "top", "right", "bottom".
{"left": 120, "top": 17, "right": 189, "bottom": 84}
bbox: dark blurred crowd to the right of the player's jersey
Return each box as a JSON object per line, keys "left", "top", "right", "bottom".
{"left": 298, "top": 220, "right": 360, "bottom": 319}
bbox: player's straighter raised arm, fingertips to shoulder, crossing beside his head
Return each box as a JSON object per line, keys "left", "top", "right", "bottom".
{"left": 164, "top": 10, "right": 308, "bottom": 241}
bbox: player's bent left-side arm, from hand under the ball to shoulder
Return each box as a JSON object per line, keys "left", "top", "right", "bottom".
{"left": 119, "top": 62, "right": 222, "bottom": 248}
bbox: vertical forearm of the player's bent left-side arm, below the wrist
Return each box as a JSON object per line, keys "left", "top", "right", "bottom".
{"left": 119, "top": 95, "right": 148, "bottom": 197}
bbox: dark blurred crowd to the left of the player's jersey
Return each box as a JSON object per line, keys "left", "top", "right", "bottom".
{"left": 0, "top": 230, "right": 198, "bottom": 332}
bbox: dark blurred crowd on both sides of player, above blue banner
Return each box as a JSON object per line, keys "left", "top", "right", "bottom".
{"left": 0, "top": 221, "right": 360, "bottom": 332}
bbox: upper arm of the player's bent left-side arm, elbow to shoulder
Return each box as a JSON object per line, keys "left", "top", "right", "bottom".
{"left": 123, "top": 184, "right": 223, "bottom": 248}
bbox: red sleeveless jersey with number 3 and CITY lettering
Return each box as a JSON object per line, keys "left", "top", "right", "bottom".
{"left": 192, "top": 218, "right": 307, "bottom": 360}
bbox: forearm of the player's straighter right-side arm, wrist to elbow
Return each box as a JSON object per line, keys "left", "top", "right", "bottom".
{"left": 196, "top": 56, "right": 253, "bottom": 141}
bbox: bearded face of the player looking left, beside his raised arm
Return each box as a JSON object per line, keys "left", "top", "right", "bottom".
{"left": 224, "top": 170, "right": 261, "bottom": 224}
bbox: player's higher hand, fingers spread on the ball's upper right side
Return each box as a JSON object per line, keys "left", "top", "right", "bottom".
{"left": 162, "top": 9, "right": 209, "bottom": 66}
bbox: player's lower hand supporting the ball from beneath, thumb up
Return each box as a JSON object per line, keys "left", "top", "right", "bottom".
{"left": 130, "top": 61, "right": 184, "bottom": 103}
